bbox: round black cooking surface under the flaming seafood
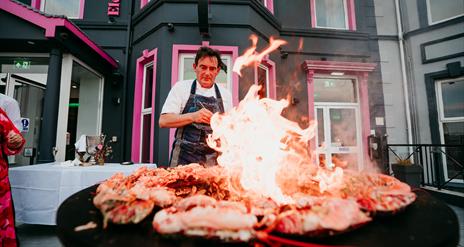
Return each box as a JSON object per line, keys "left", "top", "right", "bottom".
{"left": 57, "top": 185, "right": 459, "bottom": 247}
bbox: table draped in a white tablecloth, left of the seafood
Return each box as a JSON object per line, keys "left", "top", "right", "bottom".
{"left": 9, "top": 162, "right": 156, "bottom": 225}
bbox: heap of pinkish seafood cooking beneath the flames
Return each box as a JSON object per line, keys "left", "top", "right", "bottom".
{"left": 93, "top": 164, "right": 416, "bottom": 241}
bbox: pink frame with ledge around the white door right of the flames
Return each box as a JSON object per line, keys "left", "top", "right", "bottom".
{"left": 303, "top": 60, "right": 376, "bottom": 170}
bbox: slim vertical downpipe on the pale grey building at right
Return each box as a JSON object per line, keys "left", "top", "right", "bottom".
{"left": 395, "top": 0, "right": 412, "bottom": 147}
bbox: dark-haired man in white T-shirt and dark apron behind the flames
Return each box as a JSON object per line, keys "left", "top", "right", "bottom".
{"left": 159, "top": 47, "right": 232, "bottom": 167}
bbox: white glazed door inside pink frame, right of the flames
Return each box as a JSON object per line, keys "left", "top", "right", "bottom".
{"left": 314, "top": 76, "right": 363, "bottom": 170}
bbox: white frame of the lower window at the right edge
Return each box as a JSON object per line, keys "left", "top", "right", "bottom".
{"left": 435, "top": 77, "right": 464, "bottom": 183}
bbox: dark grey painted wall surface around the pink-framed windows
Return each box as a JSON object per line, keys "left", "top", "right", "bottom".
{"left": 125, "top": 0, "right": 384, "bottom": 165}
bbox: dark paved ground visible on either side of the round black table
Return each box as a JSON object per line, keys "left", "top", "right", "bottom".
{"left": 17, "top": 206, "right": 464, "bottom": 247}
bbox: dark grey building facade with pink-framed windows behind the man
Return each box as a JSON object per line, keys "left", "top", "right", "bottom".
{"left": 0, "top": 0, "right": 385, "bottom": 169}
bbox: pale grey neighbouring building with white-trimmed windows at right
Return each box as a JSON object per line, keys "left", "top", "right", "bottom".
{"left": 374, "top": 0, "right": 464, "bottom": 187}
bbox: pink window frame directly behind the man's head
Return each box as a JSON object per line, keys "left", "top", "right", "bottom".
{"left": 169, "top": 41, "right": 239, "bottom": 155}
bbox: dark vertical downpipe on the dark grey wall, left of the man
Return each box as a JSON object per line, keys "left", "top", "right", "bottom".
{"left": 121, "top": 0, "right": 134, "bottom": 161}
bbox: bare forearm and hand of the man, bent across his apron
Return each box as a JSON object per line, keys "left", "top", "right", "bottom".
{"left": 159, "top": 108, "right": 213, "bottom": 128}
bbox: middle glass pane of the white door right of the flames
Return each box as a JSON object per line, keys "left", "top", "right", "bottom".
{"left": 329, "top": 109, "right": 357, "bottom": 147}
